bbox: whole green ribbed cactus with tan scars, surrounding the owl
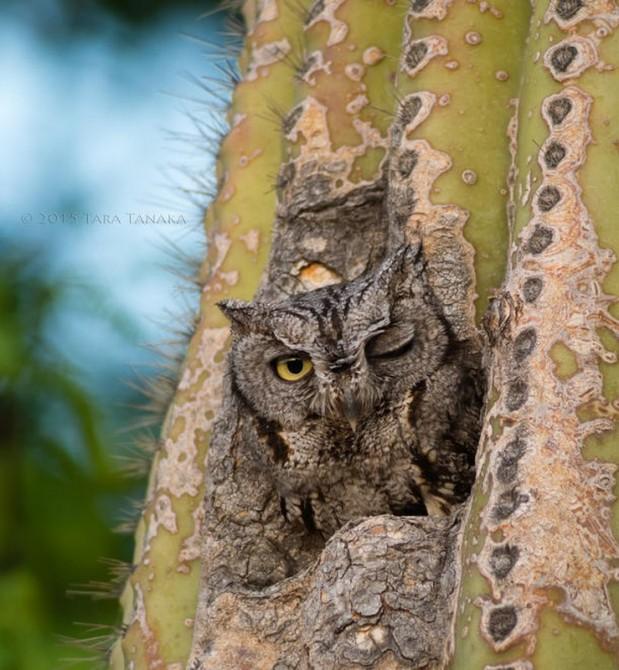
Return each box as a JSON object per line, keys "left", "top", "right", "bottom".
{"left": 110, "top": 0, "right": 619, "bottom": 670}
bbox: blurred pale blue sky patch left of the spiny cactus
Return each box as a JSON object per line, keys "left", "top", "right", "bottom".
{"left": 0, "top": 1, "right": 228, "bottom": 384}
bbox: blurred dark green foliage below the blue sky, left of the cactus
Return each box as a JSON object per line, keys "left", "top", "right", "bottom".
{"left": 0, "top": 241, "right": 154, "bottom": 670}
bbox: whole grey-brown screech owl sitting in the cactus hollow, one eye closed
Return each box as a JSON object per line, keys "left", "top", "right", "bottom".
{"left": 220, "top": 245, "right": 484, "bottom": 537}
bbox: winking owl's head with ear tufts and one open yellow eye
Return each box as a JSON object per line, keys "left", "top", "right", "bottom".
{"left": 219, "top": 246, "right": 449, "bottom": 430}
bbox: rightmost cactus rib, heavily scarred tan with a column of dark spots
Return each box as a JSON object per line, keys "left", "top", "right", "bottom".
{"left": 453, "top": 0, "right": 619, "bottom": 670}
